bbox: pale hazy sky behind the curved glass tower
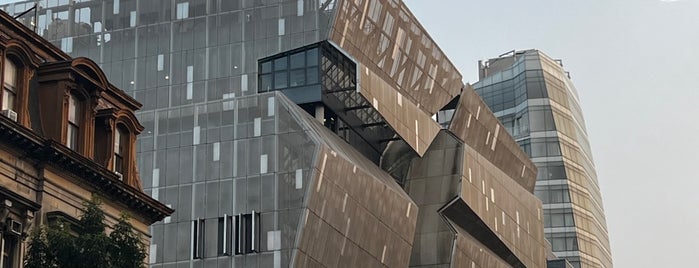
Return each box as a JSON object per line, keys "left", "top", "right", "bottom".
{"left": 404, "top": 0, "right": 699, "bottom": 267}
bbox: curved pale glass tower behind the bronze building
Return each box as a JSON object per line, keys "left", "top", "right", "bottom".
{"left": 474, "top": 50, "right": 612, "bottom": 267}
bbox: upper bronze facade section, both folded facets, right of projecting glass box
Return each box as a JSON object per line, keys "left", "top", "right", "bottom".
{"left": 328, "top": 0, "right": 462, "bottom": 156}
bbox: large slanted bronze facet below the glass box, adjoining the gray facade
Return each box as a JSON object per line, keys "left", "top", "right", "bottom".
{"left": 279, "top": 92, "right": 418, "bottom": 267}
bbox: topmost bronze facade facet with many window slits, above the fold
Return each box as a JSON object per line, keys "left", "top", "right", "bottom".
{"left": 328, "top": 0, "right": 462, "bottom": 115}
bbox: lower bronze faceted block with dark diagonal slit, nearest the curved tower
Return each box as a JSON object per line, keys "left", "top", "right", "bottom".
{"left": 405, "top": 130, "right": 546, "bottom": 267}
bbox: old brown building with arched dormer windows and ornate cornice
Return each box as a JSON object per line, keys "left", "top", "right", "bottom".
{"left": 0, "top": 9, "right": 173, "bottom": 268}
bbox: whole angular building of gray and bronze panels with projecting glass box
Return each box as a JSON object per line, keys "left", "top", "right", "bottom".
{"left": 5, "top": 0, "right": 546, "bottom": 267}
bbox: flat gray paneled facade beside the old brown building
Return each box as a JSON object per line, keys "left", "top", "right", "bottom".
{"left": 2, "top": 0, "right": 336, "bottom": 267}
